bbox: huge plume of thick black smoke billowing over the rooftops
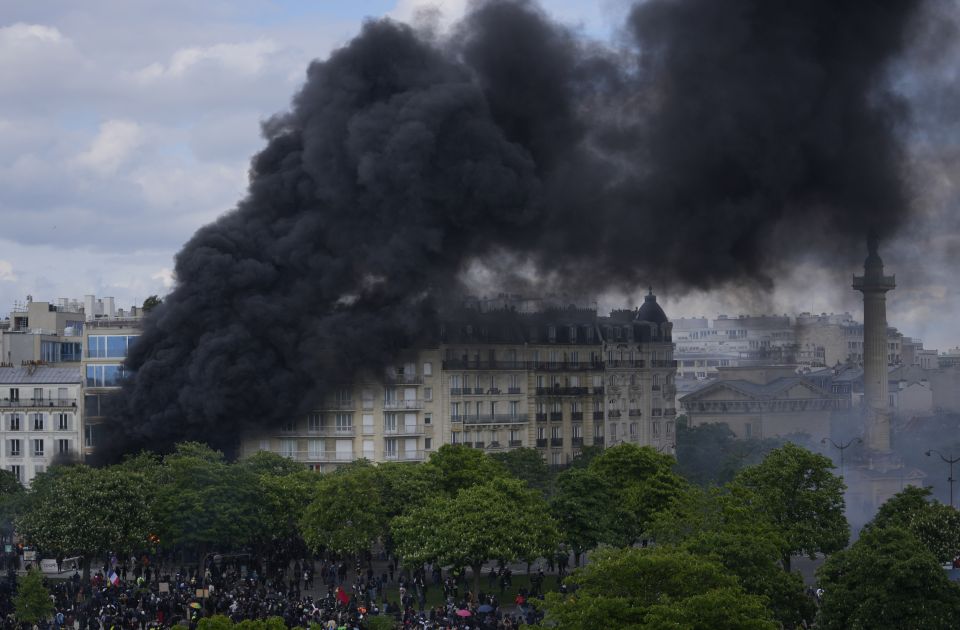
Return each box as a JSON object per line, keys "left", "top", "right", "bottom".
{"left": 98, "top": 0, "right": 919, "bottom": 458}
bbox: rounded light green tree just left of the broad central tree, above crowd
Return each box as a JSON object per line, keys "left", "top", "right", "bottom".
{"left": 300, "top": 464, "right": 387, "bottom": 554}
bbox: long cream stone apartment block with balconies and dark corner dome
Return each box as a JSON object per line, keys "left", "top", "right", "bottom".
{"left": 240, "top": 293, "right": 676, "bottom": 470}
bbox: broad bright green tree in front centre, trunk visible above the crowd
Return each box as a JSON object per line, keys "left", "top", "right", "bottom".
{"left": 391, "top": 477, "right": 558, "bottom": 592}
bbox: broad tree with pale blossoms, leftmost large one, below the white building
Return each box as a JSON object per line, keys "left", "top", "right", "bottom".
{"left": 17, "top": 465, "right": 151, "bottom": 557}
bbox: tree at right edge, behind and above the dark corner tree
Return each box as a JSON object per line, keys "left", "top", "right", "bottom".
{"left": 867, "top": 486, "right": 960, "bottom": 563}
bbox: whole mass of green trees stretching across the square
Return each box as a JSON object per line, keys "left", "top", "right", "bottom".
{"left": 7, "top": 436, "right": 960, "bottom": 628}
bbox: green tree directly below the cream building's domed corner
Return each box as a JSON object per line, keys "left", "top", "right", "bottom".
{"left": 587, "top": 444, "right": 687, "bottom": 545}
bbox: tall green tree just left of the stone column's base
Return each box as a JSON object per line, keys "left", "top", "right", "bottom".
{"left": 734, "top": 443, "right": 850, "bottom": 572}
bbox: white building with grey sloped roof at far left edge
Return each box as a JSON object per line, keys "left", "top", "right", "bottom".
{"left": 0, "top": 365, "right": 82, "bottom": 484}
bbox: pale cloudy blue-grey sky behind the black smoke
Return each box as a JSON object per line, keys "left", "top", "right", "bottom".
{"left": 0, "top": 0, "right": 960, "bottom": 349}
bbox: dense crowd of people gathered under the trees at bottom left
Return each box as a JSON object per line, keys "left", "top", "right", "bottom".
{"left": 0, "top": 557, "right": 542, "bottom": 630}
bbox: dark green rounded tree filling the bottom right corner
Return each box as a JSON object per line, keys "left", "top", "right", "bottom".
{"left": 817, "top": 527, "right": 960, "bottom": 630}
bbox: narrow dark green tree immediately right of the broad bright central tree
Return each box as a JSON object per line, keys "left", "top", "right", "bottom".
{"left": 550, "top": 468, "right": 616, "bottom": 566}
